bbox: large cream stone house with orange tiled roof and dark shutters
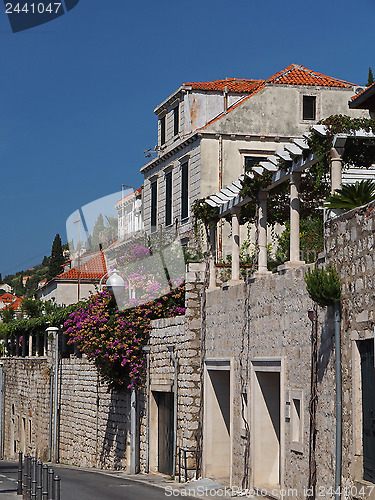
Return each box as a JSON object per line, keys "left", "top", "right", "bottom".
{"left": 141, "top": 64, "right": 363, "bottom": 255}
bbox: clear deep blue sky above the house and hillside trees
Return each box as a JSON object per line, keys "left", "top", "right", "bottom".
{"left": 0, "top": 0, "right": 375, "bottom": 277}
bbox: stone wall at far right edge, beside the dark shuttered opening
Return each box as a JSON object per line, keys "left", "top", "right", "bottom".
{"left": 326, "top": 203, "right": 375, "bottom": 498}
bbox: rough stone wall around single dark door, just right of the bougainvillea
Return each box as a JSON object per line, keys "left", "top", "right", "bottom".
{"left": 140, "top": 264, "right": 204, "bottom": 471}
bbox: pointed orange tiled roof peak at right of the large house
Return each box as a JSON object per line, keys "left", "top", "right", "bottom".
{"left": 267, "top": 64, "right": 354, "bottom": 88}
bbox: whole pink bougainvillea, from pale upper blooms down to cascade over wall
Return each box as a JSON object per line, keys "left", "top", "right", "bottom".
{"left": 64, "top": 241, "right": 185, "bottom": 388}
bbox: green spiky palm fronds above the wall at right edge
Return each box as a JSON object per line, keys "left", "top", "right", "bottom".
{"left": 326, "top": 179, "right": 375, "bottom": 210}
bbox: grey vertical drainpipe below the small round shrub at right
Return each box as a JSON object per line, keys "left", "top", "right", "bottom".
{"left": 333, "top": 302, "right": 342, "bottom": 500}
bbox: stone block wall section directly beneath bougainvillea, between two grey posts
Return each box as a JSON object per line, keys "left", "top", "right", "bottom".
{"left": 60, "top": 357, "right": 130, "bottom": 469}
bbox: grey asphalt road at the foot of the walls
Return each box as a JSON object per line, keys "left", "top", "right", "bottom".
{"left": 0, "top": 461, "right": 168, "bottom": 500}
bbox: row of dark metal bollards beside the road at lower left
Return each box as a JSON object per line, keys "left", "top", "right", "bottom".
{"left": 17, "top": 451, "right": 61, "bottom": 500}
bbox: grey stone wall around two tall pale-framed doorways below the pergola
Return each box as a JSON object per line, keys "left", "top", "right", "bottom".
{"left": 205, "top": 266, "right": 334, "bottom": 498}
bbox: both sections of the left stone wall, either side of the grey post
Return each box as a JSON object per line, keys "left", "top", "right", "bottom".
{"left": 2, "top": 357, "right": 130, "bottom": 468}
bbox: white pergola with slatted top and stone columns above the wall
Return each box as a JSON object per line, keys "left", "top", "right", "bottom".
{"left": 205, "top": 125, "right": 375, "bottom": 289}
